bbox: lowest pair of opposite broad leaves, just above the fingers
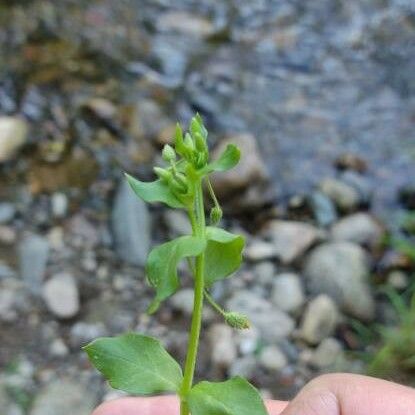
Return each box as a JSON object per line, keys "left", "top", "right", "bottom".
{"left": 84, "top": 333, "right": 267, "bottom": 415}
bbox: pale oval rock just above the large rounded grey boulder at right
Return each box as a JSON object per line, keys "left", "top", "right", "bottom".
{"left": 331, "top": 213, "right": 384, "bottom": 246}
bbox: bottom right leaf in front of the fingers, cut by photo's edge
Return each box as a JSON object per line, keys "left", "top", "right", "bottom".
{"left": 187, "top": 377, "right": 267, "bottom": 415}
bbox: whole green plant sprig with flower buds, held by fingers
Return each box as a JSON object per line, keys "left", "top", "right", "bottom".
{"left": 84, "top": 115, "right": 266, "bottom": 415}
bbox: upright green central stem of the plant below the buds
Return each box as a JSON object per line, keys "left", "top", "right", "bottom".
{"left": 180, "top": 181, "right": 206, "bottom": 415}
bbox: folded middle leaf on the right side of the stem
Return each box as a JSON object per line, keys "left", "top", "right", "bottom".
{"left": 205, "top": 226, "right": 245, "bottom": 286}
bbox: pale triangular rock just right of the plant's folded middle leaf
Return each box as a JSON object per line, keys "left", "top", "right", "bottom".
{"left": 265, "top": 220, "right": 321, "bottom": 264}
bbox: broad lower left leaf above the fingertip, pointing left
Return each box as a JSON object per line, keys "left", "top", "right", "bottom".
{"left": 83, "top": 333, "right": 183, "bottom": 395}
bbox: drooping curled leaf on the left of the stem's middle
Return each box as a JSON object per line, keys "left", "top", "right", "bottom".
{"left": 146, "top": 235, "right": 206, "bottom": 313}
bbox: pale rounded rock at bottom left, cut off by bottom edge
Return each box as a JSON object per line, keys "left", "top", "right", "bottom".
{"left": 30, "top": 379, "right": 96, "bottom": 415}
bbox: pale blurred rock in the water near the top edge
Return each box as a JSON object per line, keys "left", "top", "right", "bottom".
{"left": 157, "top": 11, "right": 214, "bottom": 38}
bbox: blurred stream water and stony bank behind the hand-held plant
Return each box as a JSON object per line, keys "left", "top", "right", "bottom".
{"left": 0, "top": 0, "right": 415, "bottom": 415}
